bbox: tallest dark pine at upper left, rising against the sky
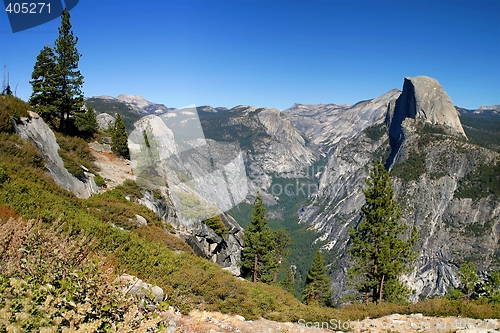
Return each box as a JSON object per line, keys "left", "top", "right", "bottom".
{"left": 54, "top": 9, "right": 83, "bottom": 131}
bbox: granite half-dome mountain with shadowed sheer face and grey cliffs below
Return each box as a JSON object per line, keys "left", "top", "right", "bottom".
{"left": 295, "top": 77, "right": 500, "bottom": 300}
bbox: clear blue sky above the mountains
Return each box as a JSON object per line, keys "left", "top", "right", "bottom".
{"left": 0, "top": 0, "right": 500, "bottom": 109}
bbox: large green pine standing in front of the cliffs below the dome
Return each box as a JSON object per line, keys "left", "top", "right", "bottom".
{"left": 348, "top": 161, "right": 418, "bottom": 303}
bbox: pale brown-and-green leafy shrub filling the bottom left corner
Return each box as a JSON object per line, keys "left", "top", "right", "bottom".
{"left": 0, "top": 219, "right": 168, "bottom": 332}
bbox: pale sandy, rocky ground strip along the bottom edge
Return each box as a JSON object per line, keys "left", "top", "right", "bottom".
{"left": 154, "top": 310, "right": 500, "bottom": 333}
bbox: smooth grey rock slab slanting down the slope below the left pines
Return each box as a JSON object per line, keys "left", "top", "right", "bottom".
{"left": 14, "top": 111, "right": 99, "bottom": 198}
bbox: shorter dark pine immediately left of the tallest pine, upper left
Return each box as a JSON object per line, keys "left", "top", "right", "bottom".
{"left": 29, "top": 46, "right": 61, "bottom": 121}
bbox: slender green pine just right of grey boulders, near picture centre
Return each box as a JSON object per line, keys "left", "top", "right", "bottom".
{"left": 240, "top": 194, "right": 277, "bottom": 283}
